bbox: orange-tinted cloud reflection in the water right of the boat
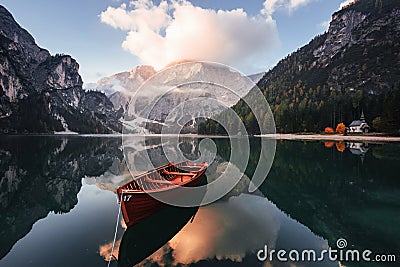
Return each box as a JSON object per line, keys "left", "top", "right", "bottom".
{"left": 139, "top": 195, "right": 280, "bottom": 266}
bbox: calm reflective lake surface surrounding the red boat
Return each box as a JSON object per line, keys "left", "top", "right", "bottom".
{"left": 0, "top": 136, "right": 400, "bottom": 267}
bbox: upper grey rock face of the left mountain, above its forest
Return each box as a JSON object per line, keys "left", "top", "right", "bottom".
{"left": 0, "top": 6, "right": 82, "bottom": 99}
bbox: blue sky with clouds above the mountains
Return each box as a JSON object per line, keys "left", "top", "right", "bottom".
{"left": 0, "top": 0, "right": 349, "bottom": 83}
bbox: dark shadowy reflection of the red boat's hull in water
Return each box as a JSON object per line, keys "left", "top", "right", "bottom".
{"left": 118, "top": 206, "right": 199, "bottom": 267}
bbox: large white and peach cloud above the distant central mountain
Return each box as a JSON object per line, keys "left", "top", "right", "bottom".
{"left": 100, "top": 0, "right": 280, "bottom": 72}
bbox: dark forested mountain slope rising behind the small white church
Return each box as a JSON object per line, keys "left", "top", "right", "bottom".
{"left": 202, "top": 0, "right": 400, "bottom": 134}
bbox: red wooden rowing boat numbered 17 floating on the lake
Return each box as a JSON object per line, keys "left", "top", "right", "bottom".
{"left": 117, "top": 162, "right": 208, "bottom": 227}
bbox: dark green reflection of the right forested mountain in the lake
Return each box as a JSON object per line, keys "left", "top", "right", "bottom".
{"left": 261, "top": 142, "right": 400, "bottom": 266}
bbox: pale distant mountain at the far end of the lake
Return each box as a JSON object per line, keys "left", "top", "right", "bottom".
{"left": 92, "top": 62, "right": 258, "bottom": 132}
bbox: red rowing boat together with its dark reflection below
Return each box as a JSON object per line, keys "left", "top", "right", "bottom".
{"left": 114, "top": 162, "right": 208, "bottom": 267}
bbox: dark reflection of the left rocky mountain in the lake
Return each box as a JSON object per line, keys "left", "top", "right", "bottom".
{"left": 0, "top": 136, "right": 122, "bottom": 259}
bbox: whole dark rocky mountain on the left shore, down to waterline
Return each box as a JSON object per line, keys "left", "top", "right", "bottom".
{"left": 0, "top": 6, "right": 122, "bottom": 133}
